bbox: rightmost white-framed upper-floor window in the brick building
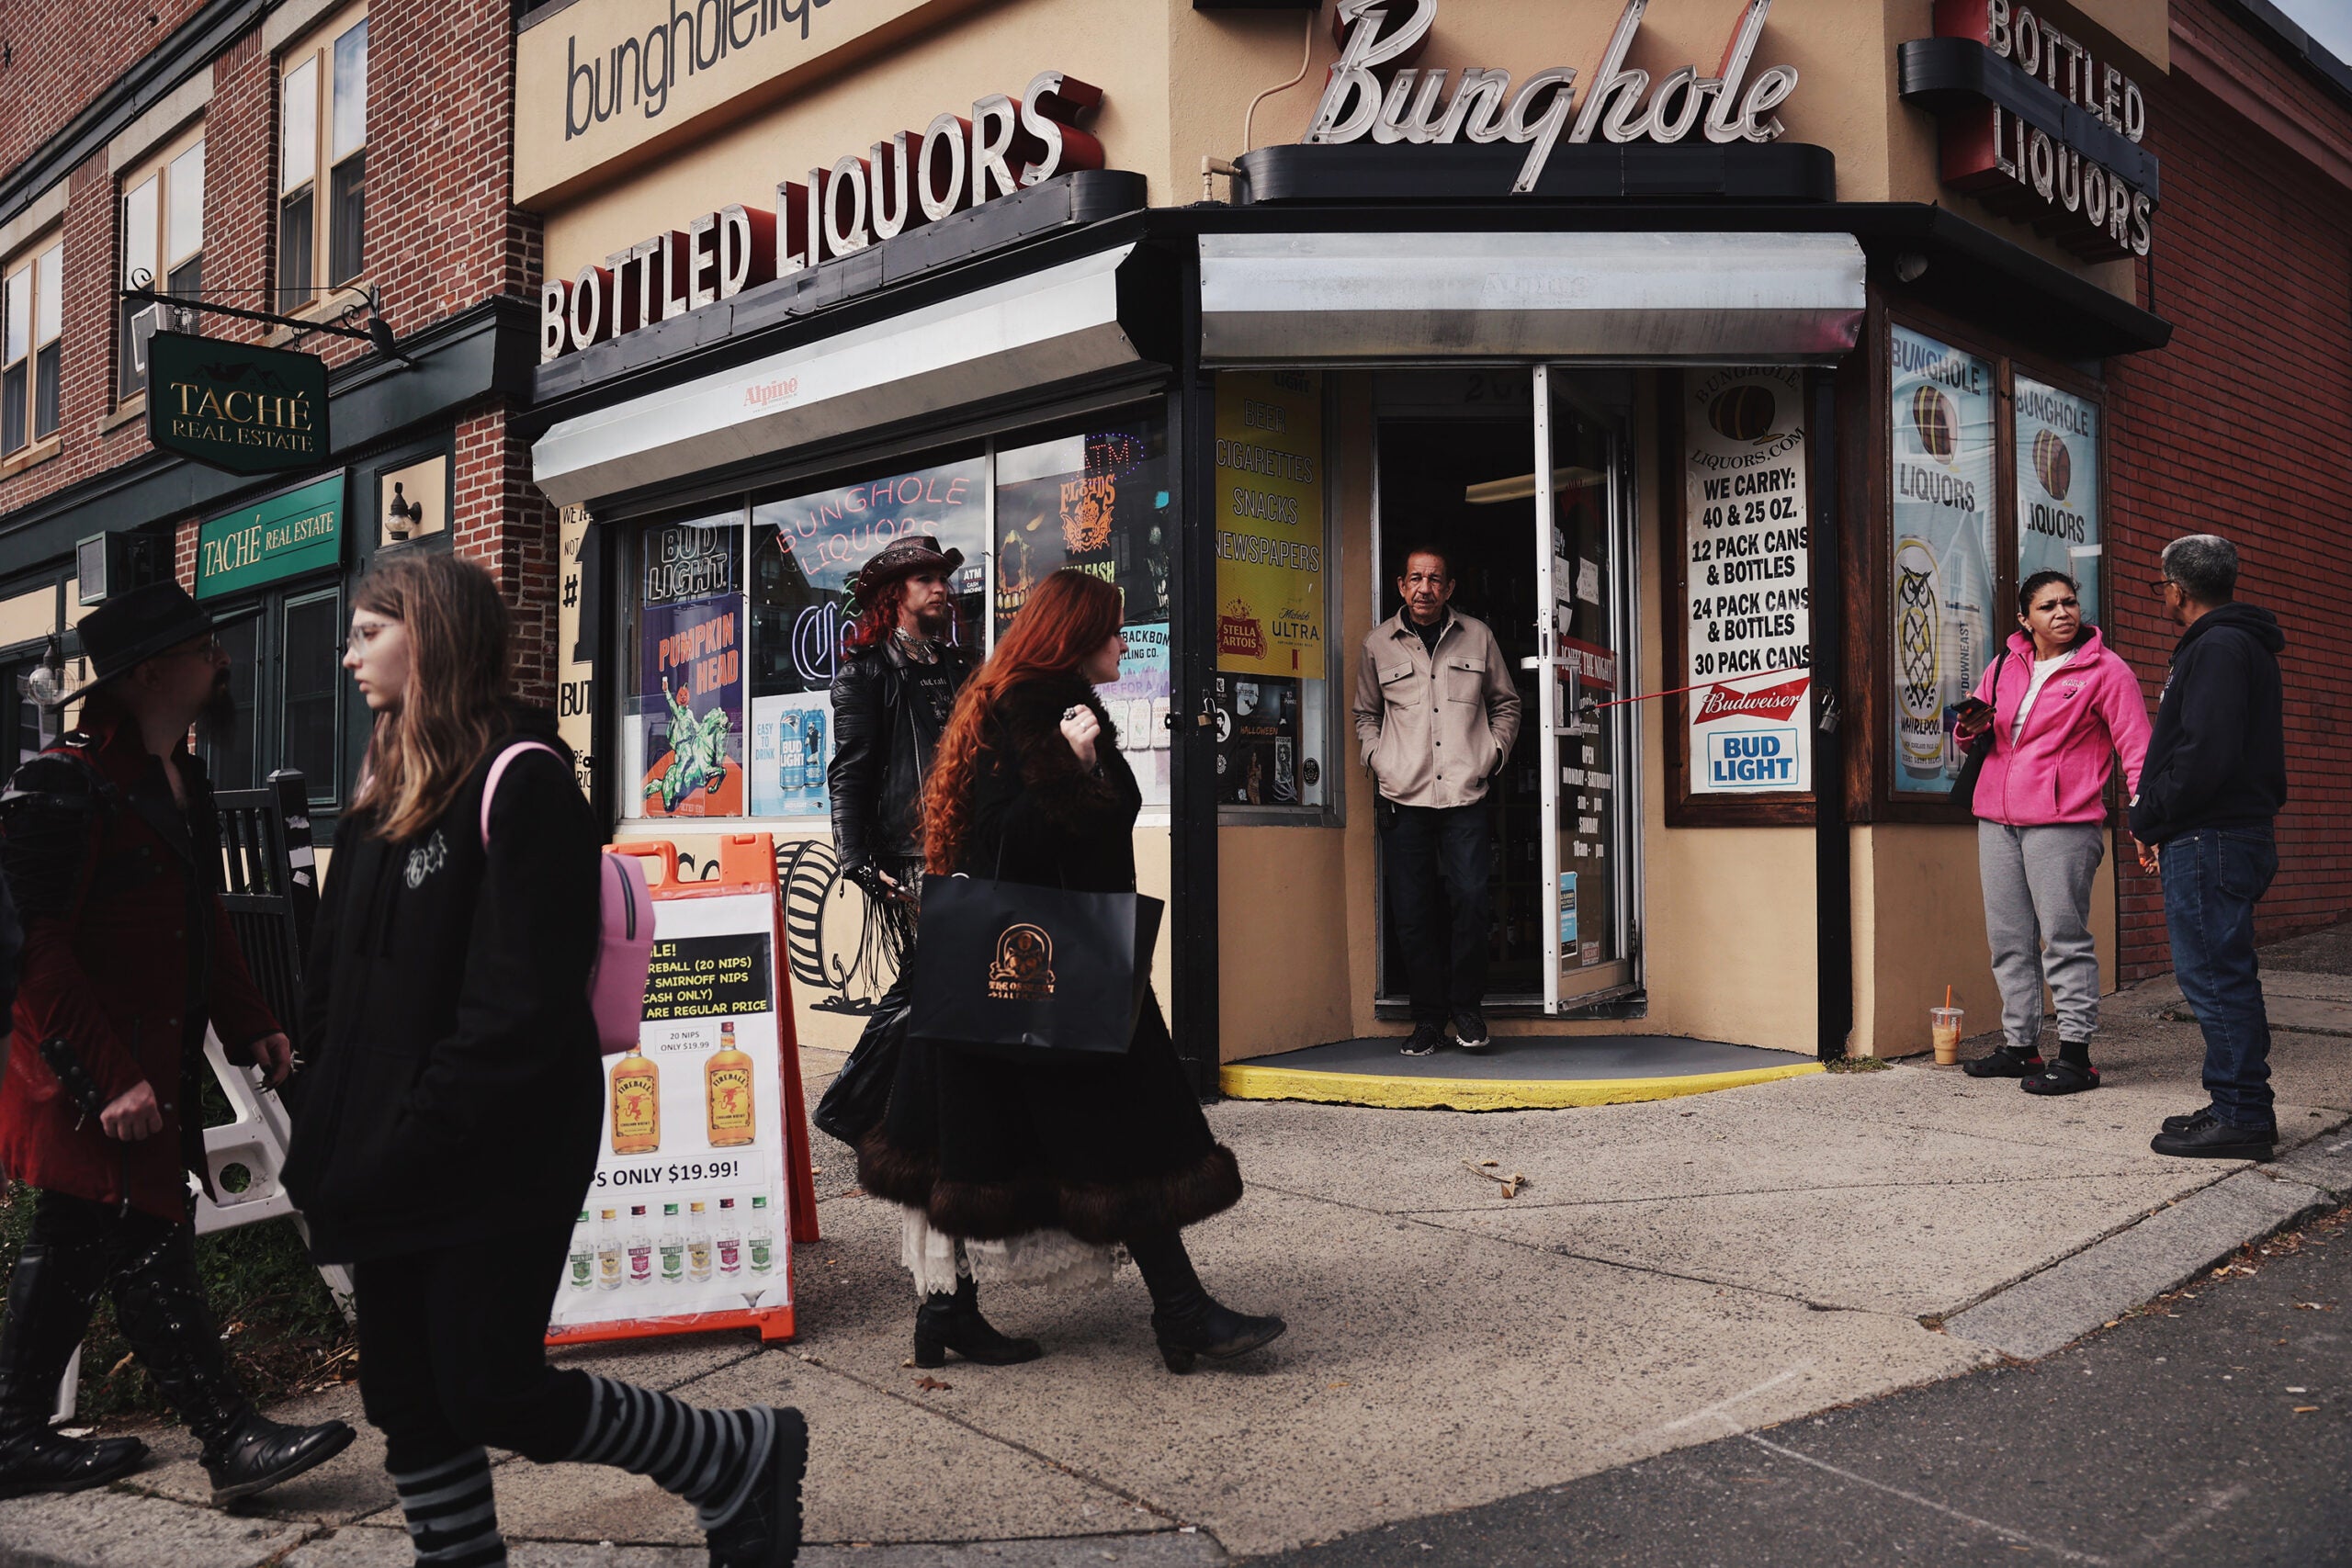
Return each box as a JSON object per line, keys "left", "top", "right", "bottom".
{"left": 277, "top": 14, "right": 367, "bottom": 310}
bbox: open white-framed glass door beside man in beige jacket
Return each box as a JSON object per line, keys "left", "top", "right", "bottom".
{"left": 1532, "top": 367, "right": 1637, "bottom": 1013}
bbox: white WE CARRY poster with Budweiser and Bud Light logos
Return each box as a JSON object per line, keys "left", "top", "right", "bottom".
{"left": 1681, "top": 367, "right": 1814, "bottom": 795}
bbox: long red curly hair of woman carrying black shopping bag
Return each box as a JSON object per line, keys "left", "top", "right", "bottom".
{"left": 922, "top": 567, "right": 1122, "bottom": 877}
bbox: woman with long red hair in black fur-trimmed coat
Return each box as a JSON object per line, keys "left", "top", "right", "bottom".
{"left": 858, "top": 569, "right": 1284, "bottom": 1373}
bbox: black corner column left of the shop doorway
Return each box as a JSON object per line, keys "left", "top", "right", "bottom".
{"left": 1169, "top": 254, "right": 1218, "bottom": 1100}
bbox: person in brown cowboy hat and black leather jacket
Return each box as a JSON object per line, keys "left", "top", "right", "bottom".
{"left": 816, "top": 534, "right": 1040, "bottom": 1366}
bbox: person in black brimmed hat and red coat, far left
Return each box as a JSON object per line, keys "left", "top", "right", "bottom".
{"left": 0, "top": 583, "right": 353, "bottom": 1502}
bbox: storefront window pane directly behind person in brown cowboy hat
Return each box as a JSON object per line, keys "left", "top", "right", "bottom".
{"left": 751, "top": 456, "right": 988, "bottom": 816}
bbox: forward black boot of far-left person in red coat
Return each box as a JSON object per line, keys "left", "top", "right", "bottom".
{"left": 113, "top": 1224, "right": 356, "bottom": 1505}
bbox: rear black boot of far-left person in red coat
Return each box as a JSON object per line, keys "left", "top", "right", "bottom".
{"left": 0, "top": 1241, "right": 146, "bottom": 1497}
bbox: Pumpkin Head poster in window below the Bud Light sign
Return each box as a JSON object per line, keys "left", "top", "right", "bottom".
{"left": 638, "top": 594, "right": 743, "bottom": 816}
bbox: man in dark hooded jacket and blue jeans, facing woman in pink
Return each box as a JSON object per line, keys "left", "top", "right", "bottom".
{"left": 2131, "top": 534, "right": 2286, "bottom": 1159}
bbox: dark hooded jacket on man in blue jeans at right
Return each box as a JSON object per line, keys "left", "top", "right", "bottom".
{"left": 2131, "top": 602, "right": 2286, "bottom": 844}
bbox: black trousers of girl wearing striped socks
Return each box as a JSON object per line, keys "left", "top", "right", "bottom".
{"left": 353, "top": 1220, "right": 591, "bottom": 1474}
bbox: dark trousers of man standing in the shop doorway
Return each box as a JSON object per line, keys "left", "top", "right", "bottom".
{"left": 1381, "top": 802, "right": 1494, "bottom": 1027}
